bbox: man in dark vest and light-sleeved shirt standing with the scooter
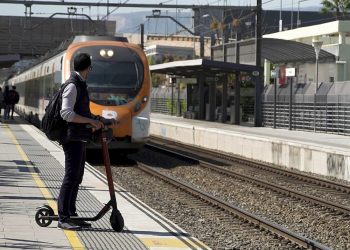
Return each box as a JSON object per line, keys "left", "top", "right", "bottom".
{"left": 57, "top": 53, "right": 104, "bottom": 230}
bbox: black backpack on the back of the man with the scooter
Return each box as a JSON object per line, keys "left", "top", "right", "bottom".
{"left": 41, "top": 83, "right": 68, "bottom": 141}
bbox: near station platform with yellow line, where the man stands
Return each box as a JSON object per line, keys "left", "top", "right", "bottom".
{"left": 0, "top": 117, "right": 209, "bottom": 250}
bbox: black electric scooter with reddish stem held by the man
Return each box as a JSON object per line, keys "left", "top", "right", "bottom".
{"left": 35, "top": 128, "right": 124, "bottom": 232}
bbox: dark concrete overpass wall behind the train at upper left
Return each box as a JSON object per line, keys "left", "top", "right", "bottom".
{"left": 0, "top": 16, "right": 115, "bottom": 56}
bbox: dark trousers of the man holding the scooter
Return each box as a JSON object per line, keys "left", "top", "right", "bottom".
{"left": 58, "top": 141, "right": 86, "bottom": 221}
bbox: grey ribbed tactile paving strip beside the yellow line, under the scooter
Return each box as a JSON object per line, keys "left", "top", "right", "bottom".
{"left": 11, "top": 125, "right": 148, "bottom": 250}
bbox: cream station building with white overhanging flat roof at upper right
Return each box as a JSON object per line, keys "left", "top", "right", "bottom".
{"left": 263, "top": 20, "right": 350, "bottom": 83}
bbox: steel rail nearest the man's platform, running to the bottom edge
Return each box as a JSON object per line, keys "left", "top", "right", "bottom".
{"left": 138, "top": 162, "right": 330, "bottom": 249}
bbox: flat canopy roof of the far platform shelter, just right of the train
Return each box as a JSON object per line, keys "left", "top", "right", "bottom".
{"left": 150, "top": 59, "right": 257, "bottom": 77}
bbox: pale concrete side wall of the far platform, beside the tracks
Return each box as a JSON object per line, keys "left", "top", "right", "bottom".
{"left": 150, "top": 120, "right": 350, "bottom": 181}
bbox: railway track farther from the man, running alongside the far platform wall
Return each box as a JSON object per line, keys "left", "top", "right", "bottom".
{"left": 147, "top": 137, "right": 350, "bottom": 215}
